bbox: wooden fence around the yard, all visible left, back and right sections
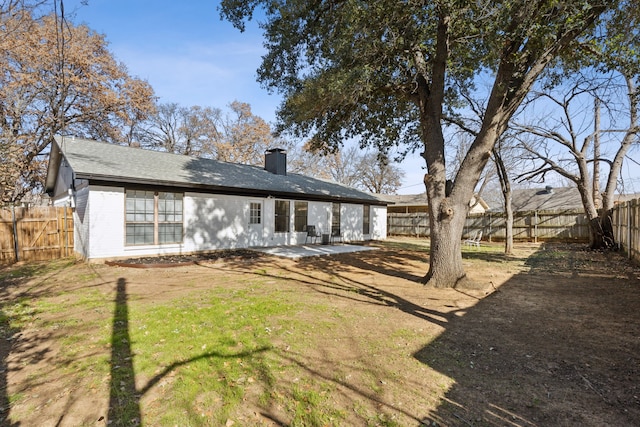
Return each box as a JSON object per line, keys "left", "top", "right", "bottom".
{"left": 0, "top": 199, "right": 640, "bottom": 264}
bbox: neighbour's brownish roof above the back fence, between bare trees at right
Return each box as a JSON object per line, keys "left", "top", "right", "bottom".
{"left": 511, "top": 187, "right": 583, "bottom": 211}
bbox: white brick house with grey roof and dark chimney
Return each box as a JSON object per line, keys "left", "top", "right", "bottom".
{"left": 46, "top": 137, "right": 387, "bottom": 260}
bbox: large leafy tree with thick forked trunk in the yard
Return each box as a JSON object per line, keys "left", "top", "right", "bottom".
{"left": 221, "top": 0, "right": 627, "bottom": 287}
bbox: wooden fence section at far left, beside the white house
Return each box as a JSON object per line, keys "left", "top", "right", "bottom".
{"left": 0, "top": 207, "right": 73, "bottom": 264}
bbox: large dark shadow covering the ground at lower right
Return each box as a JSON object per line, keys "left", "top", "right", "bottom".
{"left": 414, "top": 246, "right": 640, "bottom": 427}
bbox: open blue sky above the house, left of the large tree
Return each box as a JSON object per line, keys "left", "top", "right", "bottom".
{"left": 64, "top": 0, "right": 280, "bottom": 122}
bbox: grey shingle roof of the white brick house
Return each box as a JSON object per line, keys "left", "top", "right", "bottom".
{"left": 46, "top": 137, "right": 387, "bottom": 204}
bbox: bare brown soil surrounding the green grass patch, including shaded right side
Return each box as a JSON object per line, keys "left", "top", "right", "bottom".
{"left": 0, "top": 239, "right": 640, "bottom": 427}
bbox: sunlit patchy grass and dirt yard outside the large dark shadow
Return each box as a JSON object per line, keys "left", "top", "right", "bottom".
{"left": 0, "top": 239, "right": 544, "bottom": 427}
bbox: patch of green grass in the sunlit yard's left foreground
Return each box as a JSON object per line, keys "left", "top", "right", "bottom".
{"left": 0, "top": 263, "right": 395, "bottom": 426}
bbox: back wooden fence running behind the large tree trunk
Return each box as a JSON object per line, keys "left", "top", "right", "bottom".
{"left": 387, "top": 210, "right": 589, "bottom": 242}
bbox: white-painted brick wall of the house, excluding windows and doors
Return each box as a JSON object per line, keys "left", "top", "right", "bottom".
{"left": 58, "top": 185, "right": 386, "bottom": 259}
